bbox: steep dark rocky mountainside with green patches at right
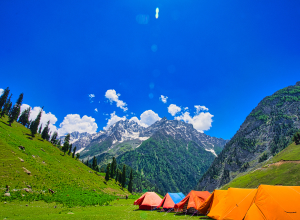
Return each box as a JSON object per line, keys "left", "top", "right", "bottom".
{"left": 196, "top": 82, "right": 300, "bottom": 191}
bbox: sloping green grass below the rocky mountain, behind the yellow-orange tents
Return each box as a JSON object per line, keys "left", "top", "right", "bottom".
{"left": 222, "top": 143, "right": 300, "bottom": 189}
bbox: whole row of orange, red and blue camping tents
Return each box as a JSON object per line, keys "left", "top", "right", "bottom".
{"left": 134, "top": 185, "right": 300, "bottom": 220}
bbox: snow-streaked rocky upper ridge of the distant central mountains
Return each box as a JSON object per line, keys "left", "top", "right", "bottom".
{"left": 60, "top": 117, "right": 227, "bottom": 158}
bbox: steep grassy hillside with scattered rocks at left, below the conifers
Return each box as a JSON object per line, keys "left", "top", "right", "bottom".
{"left": 0, "top": 118, "right": 130, "bottom": 206}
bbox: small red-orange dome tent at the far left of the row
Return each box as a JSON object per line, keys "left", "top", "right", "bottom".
{"left": 133, "top": 192, "right": 162, "bottom": 210}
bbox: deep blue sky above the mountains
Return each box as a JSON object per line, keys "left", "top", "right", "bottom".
{"left": 0, "top": 0, "right": 300, "bottom": 139}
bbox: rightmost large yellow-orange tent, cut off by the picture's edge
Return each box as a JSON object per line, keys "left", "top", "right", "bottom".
{"left": 245, "top": 185, "right": 300, "bottom": 220}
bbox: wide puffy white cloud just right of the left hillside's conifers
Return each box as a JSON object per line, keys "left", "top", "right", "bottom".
{"left": 58, "top": 114, "right": 98, "bottom": 136}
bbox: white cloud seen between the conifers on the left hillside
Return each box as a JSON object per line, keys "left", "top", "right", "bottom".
{"left": 20, "top": 104, "right": 57, "bottom": 133}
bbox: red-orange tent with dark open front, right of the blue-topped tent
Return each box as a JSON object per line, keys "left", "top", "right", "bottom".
{"left": 174, "top": 190, "right": 210, "bottom": 213}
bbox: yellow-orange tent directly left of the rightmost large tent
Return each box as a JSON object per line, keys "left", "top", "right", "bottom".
{"left": 207, "top": 188, "right": 257, "bottom": 220}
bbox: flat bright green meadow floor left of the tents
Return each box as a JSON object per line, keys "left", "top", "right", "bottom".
{"left": 0, "top": 199, "right": 210, "bottom": 220}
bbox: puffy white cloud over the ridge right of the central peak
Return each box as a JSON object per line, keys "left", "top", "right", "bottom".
{"left": 175, "top": 112, "right": 214, "bottom": 133}
